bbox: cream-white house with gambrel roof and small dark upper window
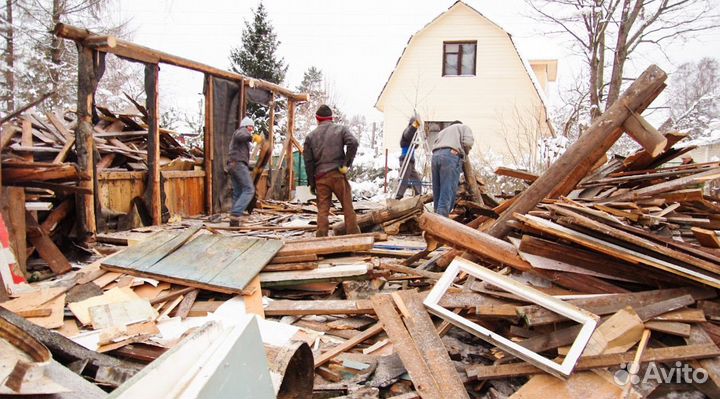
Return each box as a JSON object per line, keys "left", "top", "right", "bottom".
{"left": 375, "top": 1, "right": 557, "bottom": 168}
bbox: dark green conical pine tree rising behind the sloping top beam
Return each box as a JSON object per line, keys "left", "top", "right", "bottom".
{"left": 230, "top": 3, "right": 288, "bottom": 84}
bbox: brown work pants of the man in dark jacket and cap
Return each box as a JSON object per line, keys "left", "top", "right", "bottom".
{"left": 315, "top": 170, "right": 360, "bottom": 237}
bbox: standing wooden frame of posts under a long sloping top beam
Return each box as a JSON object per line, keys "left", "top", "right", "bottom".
{"left": 53, "top": 23, "right": 309, "bottom": 241}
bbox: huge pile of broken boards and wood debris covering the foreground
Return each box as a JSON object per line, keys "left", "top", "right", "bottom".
{"left": 0, "top": 64, "right": 720, "bottom": 399}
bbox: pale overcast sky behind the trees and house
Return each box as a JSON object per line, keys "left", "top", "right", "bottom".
{"left": 116, "top": 0, "right": 720, "bottom": 121}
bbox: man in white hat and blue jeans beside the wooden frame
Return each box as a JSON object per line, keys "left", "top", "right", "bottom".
{"left": 227, "top": 117, "right": 262, "bottom": 226}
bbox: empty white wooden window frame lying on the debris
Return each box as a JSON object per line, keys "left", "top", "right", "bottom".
{"left": 423, "top": 258, "right": 599, "bottom": 378}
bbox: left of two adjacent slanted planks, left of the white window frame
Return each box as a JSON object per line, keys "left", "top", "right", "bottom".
{"left": 372, "top": 295, "right": 443, "bottom": 399}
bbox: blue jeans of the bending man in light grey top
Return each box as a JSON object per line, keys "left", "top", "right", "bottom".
{"left": 432, "top": 148, "right": 462, "bottom": 217}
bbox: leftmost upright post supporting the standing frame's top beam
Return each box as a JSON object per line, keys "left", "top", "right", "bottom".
{"left": 75, "top": 45, "right": 105, "bottom": 243}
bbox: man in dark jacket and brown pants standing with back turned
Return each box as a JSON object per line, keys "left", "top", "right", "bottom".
{"left": 303, "top": 104, "right": 360, "bottom": 237}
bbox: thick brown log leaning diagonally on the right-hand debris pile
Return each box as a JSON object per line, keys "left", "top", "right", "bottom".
{"left": 488, "top": 65, "right": 667, "bottom": 238}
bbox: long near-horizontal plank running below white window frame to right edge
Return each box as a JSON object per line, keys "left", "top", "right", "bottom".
{"left": 465, "top": 344, "right": 720, "bottom": 380}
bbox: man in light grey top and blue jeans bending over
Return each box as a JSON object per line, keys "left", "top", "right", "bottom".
{"left": 432, "top": 121, "right": 474, "bottom": 217}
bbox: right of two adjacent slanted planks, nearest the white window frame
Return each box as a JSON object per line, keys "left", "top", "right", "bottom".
{"left": 393, "top": 291, "right": 469, "bottom": 398}
